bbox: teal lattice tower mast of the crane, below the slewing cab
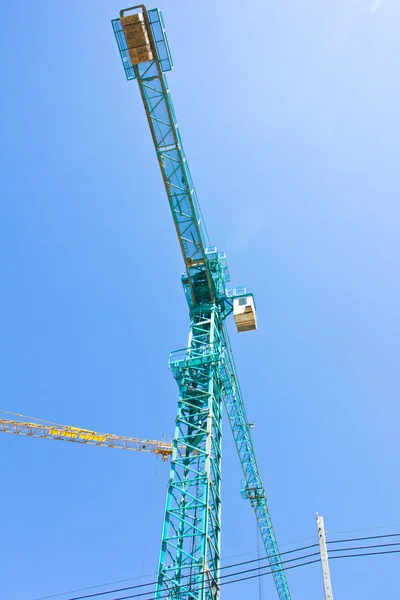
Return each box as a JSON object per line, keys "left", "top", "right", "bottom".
{"left": 164, "top": 303, "right": 223, "bottom": 600}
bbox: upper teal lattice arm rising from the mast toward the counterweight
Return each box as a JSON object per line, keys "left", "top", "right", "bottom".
{"left": 112, "top": 9, "right": 215, "bottom": 304}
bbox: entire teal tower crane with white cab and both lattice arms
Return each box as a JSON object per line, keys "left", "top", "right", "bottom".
{"left": 112, "top": 5, "right": 290, "bottom": 600}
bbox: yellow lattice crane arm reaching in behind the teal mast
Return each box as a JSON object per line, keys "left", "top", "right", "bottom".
{"left": 0, "top": 410, "right": 173, "bottom": 461}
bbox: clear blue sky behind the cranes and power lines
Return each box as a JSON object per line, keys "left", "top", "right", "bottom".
{"left": 0, "top": 0, "right": 400, "bottom": 600}
